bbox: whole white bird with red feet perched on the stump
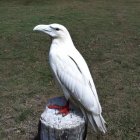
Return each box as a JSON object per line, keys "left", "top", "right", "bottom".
{"left": 33, "top": 23, "right": 107, "bottom": 133}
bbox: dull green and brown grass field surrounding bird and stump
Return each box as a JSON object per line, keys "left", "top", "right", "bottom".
{"left": 0, "top": 0, "right": 140, "bottom": 140}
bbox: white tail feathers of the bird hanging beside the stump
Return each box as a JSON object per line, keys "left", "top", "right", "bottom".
{"left": 87, "top": 113, "right": 107, "bottom": 133}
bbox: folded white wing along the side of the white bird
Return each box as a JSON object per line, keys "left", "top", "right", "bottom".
{"left": 50, "top": 49, "right": 101, "bottom": 114}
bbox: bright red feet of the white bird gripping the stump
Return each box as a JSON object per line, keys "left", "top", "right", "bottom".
{"left": 48, "top": 102, "right": 70, "bottom": 116}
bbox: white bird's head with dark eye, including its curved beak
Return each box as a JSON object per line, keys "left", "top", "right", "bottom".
{"left": 33, "top": 23, "right": 69, "bottom": 38}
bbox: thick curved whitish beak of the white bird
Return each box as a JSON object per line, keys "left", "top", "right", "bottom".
{"left": 33, "top": 24, "right": 51, "bottom": 32}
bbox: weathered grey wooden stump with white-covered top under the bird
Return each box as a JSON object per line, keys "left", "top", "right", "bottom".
{"left": 40, "top": 97, "right": 87, "bottom": 140}
